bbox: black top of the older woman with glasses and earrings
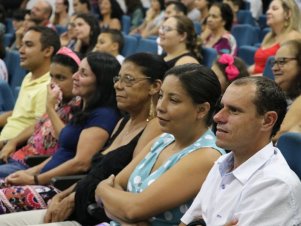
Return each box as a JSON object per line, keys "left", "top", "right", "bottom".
{"left": 69, "top": 117, "right": 144, "bottom": 225}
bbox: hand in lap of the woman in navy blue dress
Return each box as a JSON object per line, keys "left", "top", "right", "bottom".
{"left": 5, "top": 170, "right": 35, "bottom": 185}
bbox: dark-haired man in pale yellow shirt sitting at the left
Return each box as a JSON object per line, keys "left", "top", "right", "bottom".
{"left": 0, "top": 26, "right": 60, "bottom": 143}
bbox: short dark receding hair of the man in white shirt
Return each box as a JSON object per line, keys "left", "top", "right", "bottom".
{"left": 232, "top": 76, "right": 287, "bottom": 137}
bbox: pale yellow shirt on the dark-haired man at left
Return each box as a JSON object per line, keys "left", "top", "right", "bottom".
{"left": 0, "top": 72, "right": 50, "bottom": 140}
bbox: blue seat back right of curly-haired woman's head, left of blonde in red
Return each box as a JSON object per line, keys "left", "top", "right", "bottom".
{"left": 231, "top": 24, "right": 258, "bottom": 47}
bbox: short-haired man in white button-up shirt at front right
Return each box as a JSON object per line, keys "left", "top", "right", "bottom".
{"left": 181, "top": 77, "right": 301, "bottom": 226}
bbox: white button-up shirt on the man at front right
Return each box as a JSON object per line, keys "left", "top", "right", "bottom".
{"left": 181, "top": 143, "right": 301, "bottom": 226}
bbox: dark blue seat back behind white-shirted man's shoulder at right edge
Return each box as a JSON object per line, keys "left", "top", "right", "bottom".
{"left": 277, "top": 132, "right": 301, "bottom": 179}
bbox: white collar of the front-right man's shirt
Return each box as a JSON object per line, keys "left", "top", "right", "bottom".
{"left": 217, "top": 142, "right": 277, "bottom": 184}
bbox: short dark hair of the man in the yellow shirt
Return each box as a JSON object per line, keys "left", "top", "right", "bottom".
{"left": 27, "top": 26, "right": 61, "bottom": 56}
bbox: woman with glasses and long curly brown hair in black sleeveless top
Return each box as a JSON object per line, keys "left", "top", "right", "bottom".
{"left": 159, "top": 16, "right": 202, "bottom": 68}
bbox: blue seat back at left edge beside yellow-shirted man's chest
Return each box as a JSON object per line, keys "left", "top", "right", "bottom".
{"left": 0, "top": 79, "right": 15, "bottom": 111}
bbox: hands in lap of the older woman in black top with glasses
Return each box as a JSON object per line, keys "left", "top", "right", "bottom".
{"left": 44, "top": 192, "right": 75, "bottom": 223}
